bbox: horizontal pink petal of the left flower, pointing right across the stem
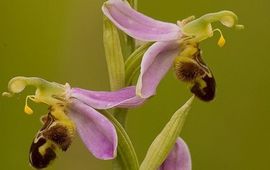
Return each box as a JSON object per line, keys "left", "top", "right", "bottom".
{"left": 71, "top": 86, "right": 145, "bottom": 109}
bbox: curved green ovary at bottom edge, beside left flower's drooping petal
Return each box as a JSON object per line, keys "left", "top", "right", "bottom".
{"left": 101, "top": 110, "right": 139, "bottom": 170}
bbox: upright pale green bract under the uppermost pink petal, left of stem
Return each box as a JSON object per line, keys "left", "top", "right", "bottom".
{"left": 103, "top": 17, "right": 125, "bottom": 91}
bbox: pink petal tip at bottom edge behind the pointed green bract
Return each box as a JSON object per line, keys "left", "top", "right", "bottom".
{"left": 159, "top": 138, "right": 191, "bottom": 170}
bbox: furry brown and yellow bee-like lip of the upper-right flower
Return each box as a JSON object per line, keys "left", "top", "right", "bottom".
{"left": 174, "top": 44, "right": 216, "bottom": 101}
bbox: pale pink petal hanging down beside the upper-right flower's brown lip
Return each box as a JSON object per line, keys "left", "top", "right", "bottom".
{"left": 136, "top": 41, "right": 179, "bottom": 98}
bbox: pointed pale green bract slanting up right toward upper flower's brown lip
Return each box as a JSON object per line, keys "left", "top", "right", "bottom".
{"left": 140, "top": 96, "right": 194, "bottom": 170}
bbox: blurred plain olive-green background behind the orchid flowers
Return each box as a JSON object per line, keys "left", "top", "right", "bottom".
{"left": 0, "top": 0, "right": 270, "bottom": 170}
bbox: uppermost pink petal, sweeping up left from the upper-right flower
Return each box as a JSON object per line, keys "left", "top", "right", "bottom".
{"left": 102, "top": 0, "right": 182, "bottom": 41}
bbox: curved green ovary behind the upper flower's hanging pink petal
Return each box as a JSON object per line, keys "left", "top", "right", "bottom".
{"left": 125, "top": 43, "right": 153, "bottom": 86}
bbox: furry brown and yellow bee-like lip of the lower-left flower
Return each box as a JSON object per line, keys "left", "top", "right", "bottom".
{"left": 29, "top": 109, "right": 74, "bottom": 169}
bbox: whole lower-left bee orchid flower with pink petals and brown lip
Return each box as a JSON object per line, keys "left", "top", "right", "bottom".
{"left": 3, "top": 77, "right": 143, "bottom": 169}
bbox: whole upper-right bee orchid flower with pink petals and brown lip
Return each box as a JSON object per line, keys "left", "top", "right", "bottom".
{"left": 102, "top": 0, "right": 243, "bottom": 101}
